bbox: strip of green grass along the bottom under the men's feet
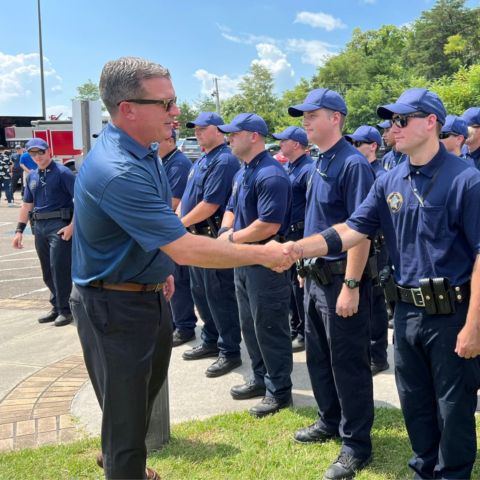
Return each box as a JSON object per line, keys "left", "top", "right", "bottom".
{"left": 0, "top": 408, "right": 480, "bottom": 480}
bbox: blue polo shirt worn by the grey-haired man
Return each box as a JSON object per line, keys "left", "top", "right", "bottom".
{"left": 72, "top": 124, "right": 186, "bottom": 286}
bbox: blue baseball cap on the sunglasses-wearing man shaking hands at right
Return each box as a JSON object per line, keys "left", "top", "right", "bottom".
{"left": 377, "top": 88, "right": 447, "bottom": 125}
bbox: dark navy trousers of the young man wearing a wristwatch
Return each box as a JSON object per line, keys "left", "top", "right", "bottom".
{"left": 305, "top": 275, "right": 373, "bottom": 458}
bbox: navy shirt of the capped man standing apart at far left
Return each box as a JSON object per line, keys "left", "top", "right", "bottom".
{"left": 23, "top": 160, "right": 75, "bottom": 212}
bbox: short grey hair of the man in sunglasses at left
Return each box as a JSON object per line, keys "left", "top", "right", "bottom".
{"left": 99, "top": 57, "right": 170, "bottom": 116}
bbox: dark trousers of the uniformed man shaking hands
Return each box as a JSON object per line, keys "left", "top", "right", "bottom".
{"left": 394, "top": 302, "right": 480, "bottom": 479}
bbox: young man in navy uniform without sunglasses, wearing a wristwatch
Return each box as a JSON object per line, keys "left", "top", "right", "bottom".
{"left": 288, "top": 88, "right": 374, "bottom": 479}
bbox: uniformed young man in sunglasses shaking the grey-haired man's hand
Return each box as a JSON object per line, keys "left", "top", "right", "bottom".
{"left": 284, "top": 88, "right": 480, "bottom": 479}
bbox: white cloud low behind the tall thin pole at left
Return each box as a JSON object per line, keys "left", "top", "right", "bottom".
{"left": 0, "top": 52, "right": 62, "bottom": 103}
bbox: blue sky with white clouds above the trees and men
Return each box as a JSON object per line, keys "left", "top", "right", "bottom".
{"left": 0, "top": 0, "right": 472, "bottom": 116}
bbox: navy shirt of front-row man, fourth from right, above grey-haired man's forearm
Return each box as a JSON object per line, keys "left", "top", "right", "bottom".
{"left": 181, "top": 144, "right": 240, "bottom": 217}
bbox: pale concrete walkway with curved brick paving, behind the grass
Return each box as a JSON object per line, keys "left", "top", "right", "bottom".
{"left": 0, "top": 306, "right": 399, "bottom": 451}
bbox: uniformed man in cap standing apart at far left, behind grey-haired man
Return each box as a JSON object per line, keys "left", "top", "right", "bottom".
{"left": 13, "top": 138, "right": 75, "bottom": 327}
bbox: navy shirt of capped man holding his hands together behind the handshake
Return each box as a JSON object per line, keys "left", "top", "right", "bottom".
{"left": 227, "top": 150, "right": 292, "bottom": 235}
